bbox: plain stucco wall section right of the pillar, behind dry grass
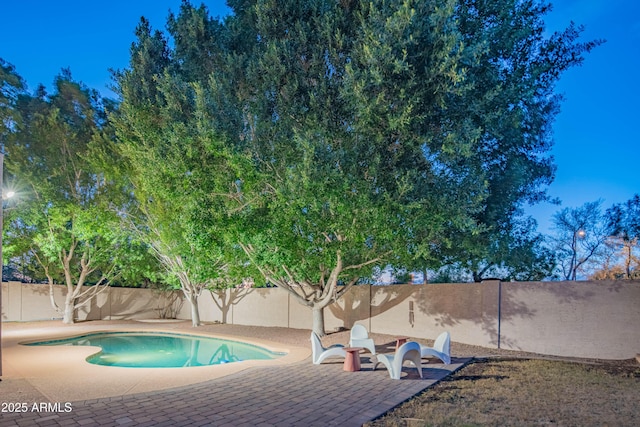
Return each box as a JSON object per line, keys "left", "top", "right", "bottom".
{"left": 500, "top": 281, "right": 640, "bottom": 359}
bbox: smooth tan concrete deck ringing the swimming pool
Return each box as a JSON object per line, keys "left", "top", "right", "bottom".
{"left": 0, "top": 321, "right": 311, "bottom": 402}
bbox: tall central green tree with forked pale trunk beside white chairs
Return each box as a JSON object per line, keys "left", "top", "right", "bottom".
{"left": 216, "top": 1, "right": 477, "bottom": 335}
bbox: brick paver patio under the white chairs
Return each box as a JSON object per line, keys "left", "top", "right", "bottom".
{"left": 0, "top": 354, "right": 470, "bottom": 427}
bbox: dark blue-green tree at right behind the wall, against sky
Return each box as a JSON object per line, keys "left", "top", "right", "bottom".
{"left": 430, "top": 0, "right": 601, "bottom": 281}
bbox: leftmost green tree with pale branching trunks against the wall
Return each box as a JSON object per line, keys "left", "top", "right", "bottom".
{"left": 3, "top": 70, "right": 146, "bottom": 323}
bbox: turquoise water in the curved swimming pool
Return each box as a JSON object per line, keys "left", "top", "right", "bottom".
{"left": 27, "top": 332, "right": 284, "bottom": 368}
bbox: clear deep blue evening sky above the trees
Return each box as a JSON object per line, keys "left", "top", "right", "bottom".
{"left": 0, "top": 0, "right": 640, "bottom": 233}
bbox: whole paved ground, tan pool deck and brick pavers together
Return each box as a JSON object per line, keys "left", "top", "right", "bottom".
{"left": 0, "top": 321, "right": 470, "bottom": 426}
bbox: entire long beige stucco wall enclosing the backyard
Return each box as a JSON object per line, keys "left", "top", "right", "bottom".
{"left": 2, "top": 281, "right": 640, "bottom": 359}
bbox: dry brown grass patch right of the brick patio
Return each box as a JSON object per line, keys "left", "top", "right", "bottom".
{"left": 366, "top": 360, "right": 640, "bottom": 427}
